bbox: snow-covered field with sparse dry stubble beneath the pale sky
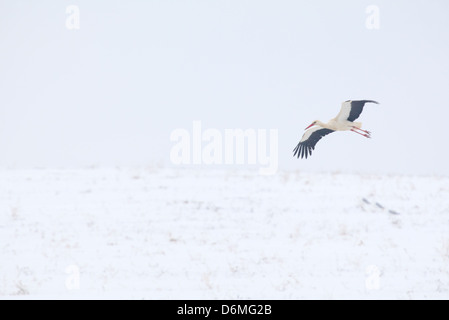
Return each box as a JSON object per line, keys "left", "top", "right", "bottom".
{"left": 0, "top": 167, "right": 449, "bottom": 299}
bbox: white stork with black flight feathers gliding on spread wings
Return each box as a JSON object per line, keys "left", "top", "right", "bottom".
{"left": 293, "top": 100, "right": 379, "bottom": 159}
